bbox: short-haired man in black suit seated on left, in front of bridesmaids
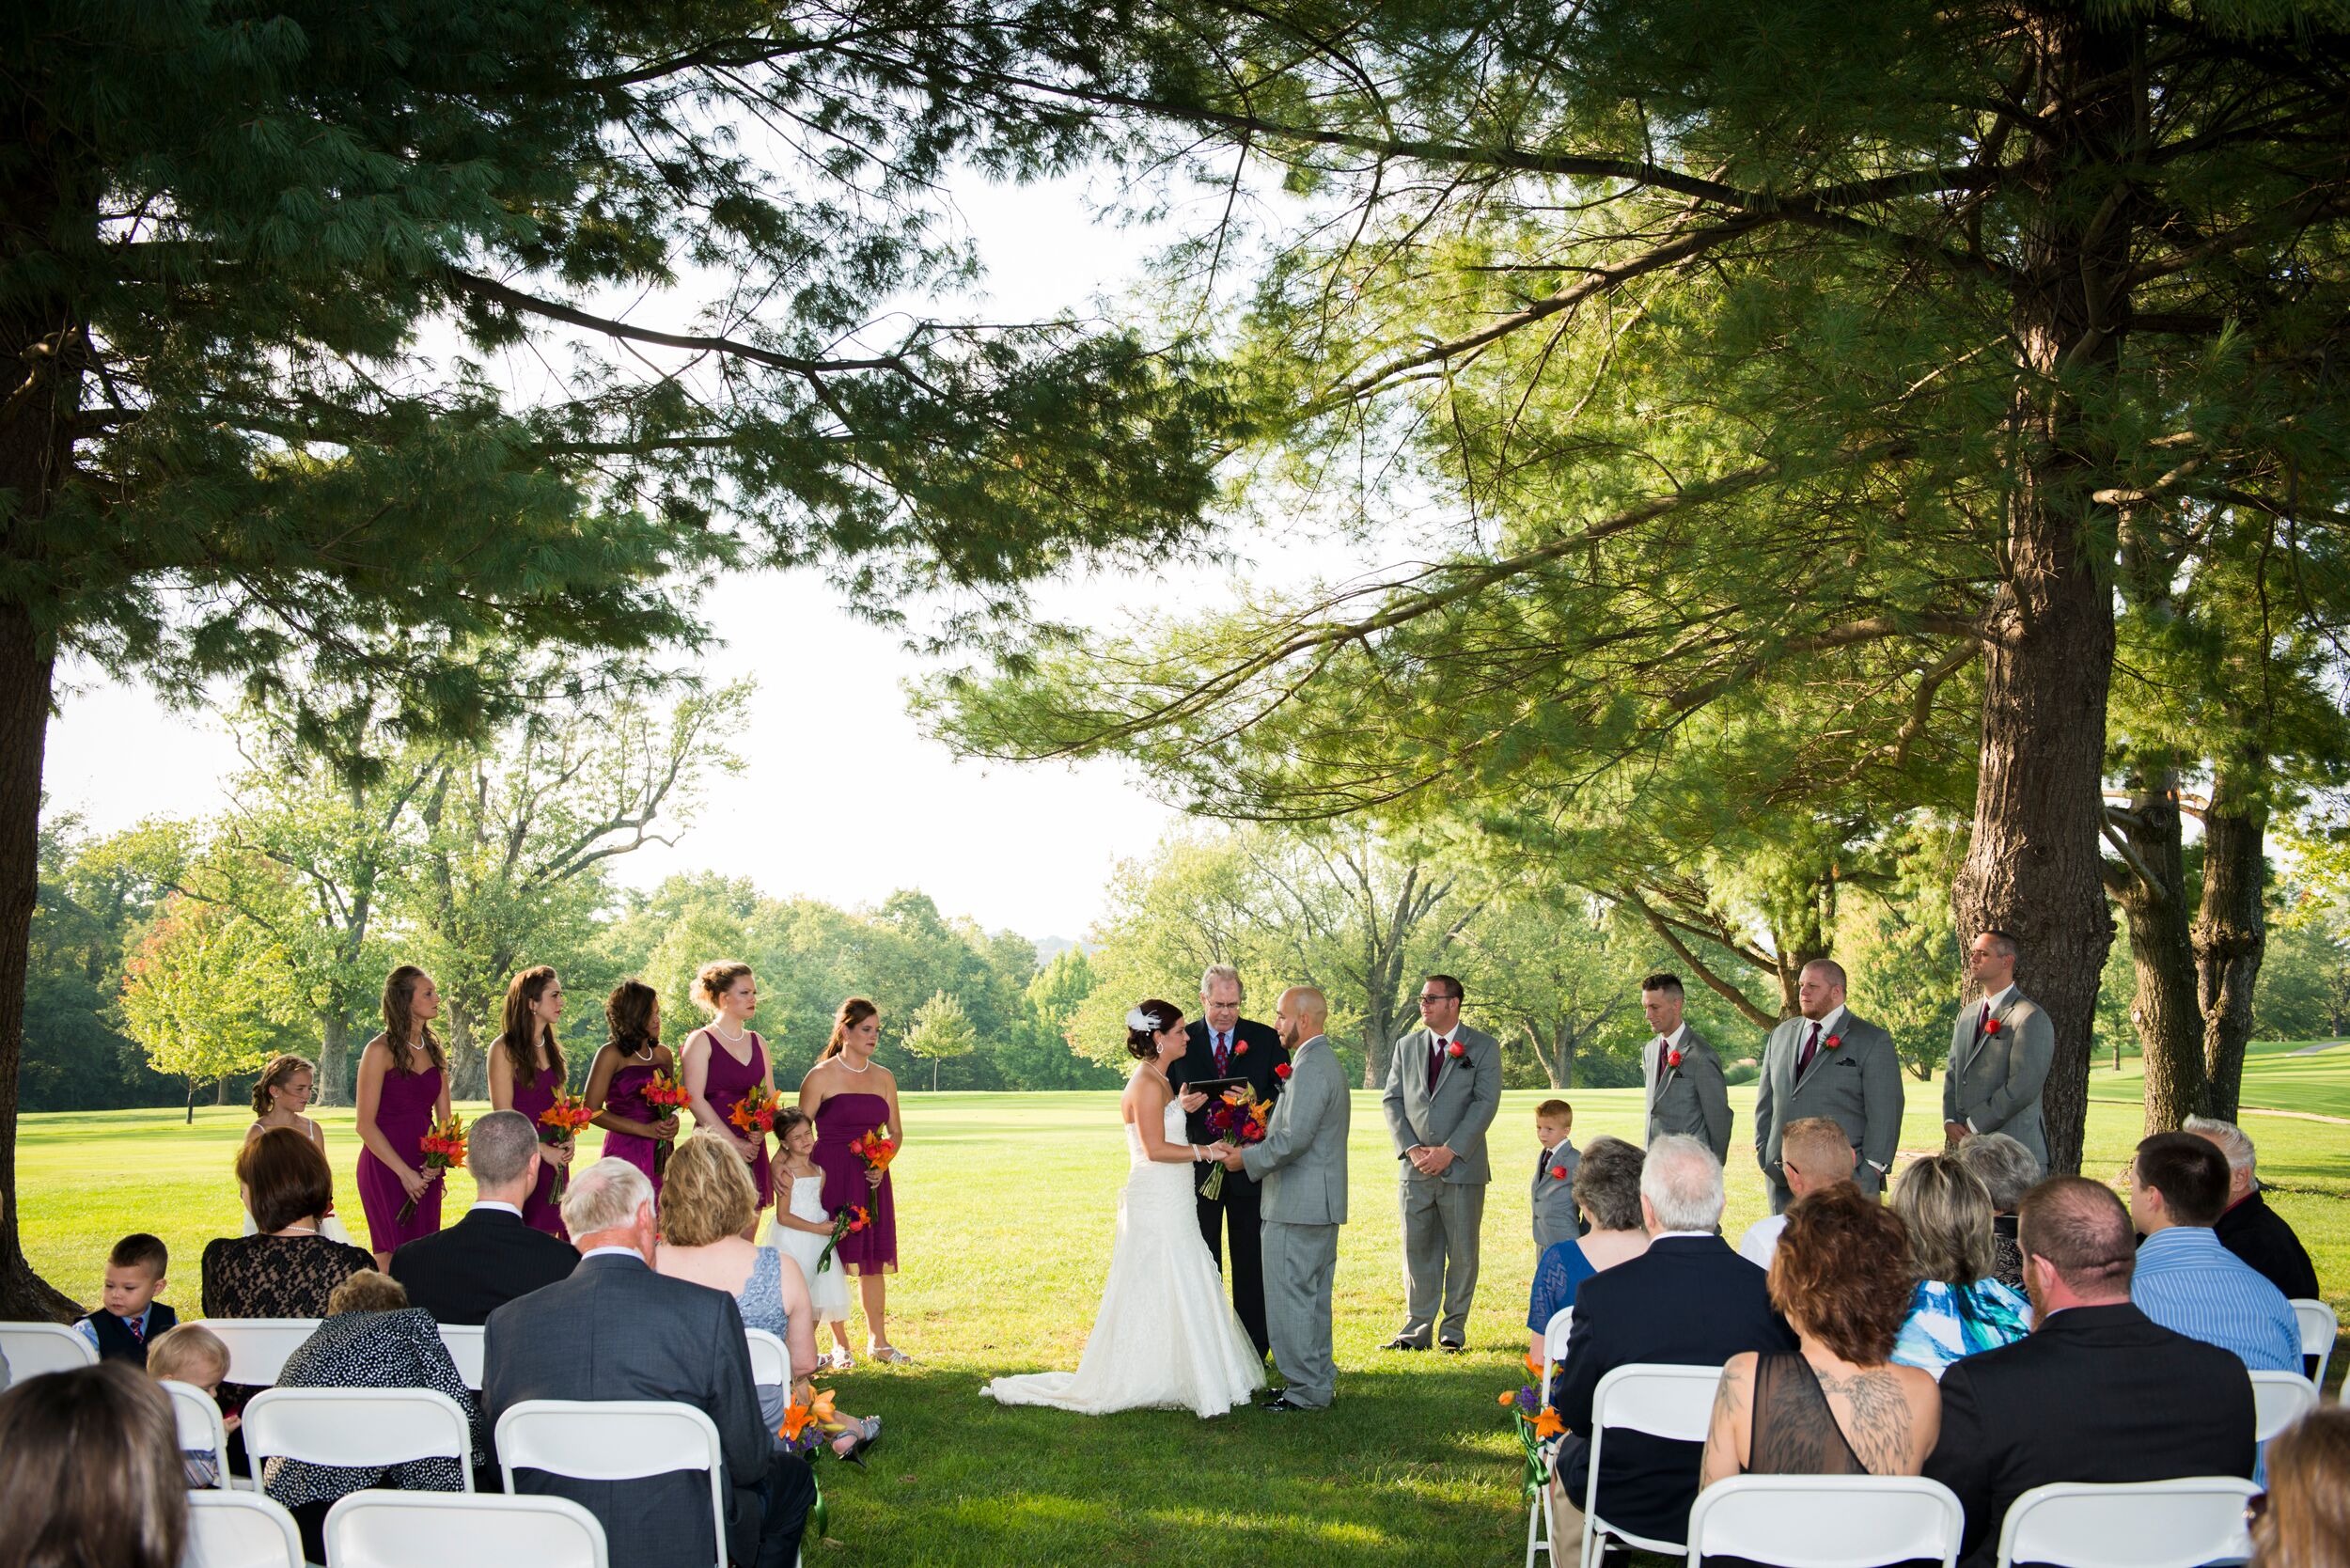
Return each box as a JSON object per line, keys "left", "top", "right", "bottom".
{"left": 393, "top": 1109, "right": 581, "bottom": 1324}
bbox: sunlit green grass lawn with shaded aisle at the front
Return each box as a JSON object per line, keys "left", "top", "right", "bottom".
{"left": 19, "top": 1048, "right": 2350, "bottom": 1568}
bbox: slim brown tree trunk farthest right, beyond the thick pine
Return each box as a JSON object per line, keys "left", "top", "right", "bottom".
{"left": 2193, "top": 752, "right": 2268, "bottom": 1121}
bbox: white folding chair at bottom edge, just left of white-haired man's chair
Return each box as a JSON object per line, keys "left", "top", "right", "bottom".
{"left": 327, "top": 1490, "right": 611, "bottom": 1568}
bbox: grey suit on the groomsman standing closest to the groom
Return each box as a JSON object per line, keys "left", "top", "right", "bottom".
{"left": 1380, "top": 1025, "right": 1502, "bottom": 1344}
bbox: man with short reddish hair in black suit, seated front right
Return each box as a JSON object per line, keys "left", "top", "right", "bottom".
{"left": 1925, "top": 1175, "right": 2254, "bottom": 1568}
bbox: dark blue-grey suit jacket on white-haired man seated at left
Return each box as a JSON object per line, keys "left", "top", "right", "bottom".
{"left": 482, "top": 1255, "right": 774, "bottom": 1568}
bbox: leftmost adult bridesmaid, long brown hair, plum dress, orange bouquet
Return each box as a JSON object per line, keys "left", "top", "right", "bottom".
{"left": 357, "top": 964, "right": 449, "bottom": 1269}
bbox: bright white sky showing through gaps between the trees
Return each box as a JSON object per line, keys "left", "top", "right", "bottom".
{"left": 47, "top": 169, "right": 1281, "bottom": 938}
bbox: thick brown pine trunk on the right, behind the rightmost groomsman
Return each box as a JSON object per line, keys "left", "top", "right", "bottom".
{"left": 1953, "top": 8, "right": 2143, "bottom": 1173}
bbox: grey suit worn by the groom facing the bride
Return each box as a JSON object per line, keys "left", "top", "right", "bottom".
{"left": 1241, "top": 1034, "right": 1352, "bottom": 1410}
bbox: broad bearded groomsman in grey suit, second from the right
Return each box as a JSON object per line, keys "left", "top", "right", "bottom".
{"left": 1756, "top": 959, "right": 1902, "bottom": 1213}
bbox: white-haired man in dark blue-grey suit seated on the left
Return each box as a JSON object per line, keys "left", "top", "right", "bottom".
{"left": 482, "top": 1159, "right": 816, "bottom": 1568}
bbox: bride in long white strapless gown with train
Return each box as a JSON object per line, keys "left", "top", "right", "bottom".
{"left": 980, "top": 999, "right": 1264, "bottom": 1415}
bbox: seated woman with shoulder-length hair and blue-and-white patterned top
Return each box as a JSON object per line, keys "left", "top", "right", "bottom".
{"left": 1894, "top": 1154, "right": 2033, "bottom": 1377}
